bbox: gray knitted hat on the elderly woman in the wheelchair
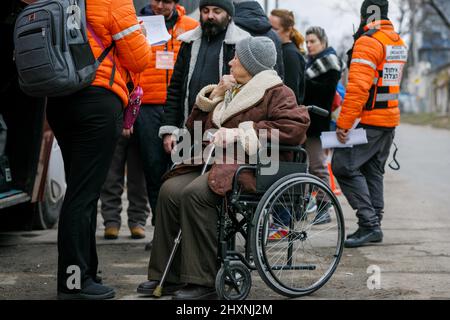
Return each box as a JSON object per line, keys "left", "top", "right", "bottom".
{"left": 236, "top": 37, "right": 277, "bottom": 76}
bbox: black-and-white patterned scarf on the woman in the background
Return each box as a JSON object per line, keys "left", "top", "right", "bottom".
{"left": 306, "top": 47, "right": 345, "bottom": 79}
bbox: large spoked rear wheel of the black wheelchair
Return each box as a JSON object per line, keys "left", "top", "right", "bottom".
{"left": 251, "top": 173, "right": 345, "bottom": 297}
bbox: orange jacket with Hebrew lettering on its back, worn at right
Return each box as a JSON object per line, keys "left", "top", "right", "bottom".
{"left": 337, "top": 20, "right": 407, "bottom": 129}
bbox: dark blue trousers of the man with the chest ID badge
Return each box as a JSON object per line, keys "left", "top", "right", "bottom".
{"left": 134, "top": 104, "right": 170, "bottom": 225}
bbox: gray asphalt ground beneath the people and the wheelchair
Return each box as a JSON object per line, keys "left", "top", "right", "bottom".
{"left": 0, "top": 125, "right": 450, "bottom": 299}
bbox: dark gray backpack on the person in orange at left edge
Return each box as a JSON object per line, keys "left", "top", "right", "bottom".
{"left": 14, "top": 0, "right": 114, "bottom": 97}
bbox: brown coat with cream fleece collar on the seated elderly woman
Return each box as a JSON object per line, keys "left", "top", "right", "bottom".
{"left": 166, "top": 70, "right": 310, "bottom": 196}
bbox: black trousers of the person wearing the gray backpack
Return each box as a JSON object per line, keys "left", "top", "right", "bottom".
{"left": 47, "top": 87, "right": 122, "bottom": 292}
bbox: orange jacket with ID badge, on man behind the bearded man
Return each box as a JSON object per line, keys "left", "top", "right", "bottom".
{"left": 139, "top": 5, "right": 199, "bottom": 104}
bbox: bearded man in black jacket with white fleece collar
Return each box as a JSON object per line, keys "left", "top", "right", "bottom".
{"left": 159, "top": 0, "right": 250, "bottom": 153}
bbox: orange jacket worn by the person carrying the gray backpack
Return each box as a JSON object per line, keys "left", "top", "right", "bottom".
{"left": 86, "top": 0, "right": 151, "bottom": 106}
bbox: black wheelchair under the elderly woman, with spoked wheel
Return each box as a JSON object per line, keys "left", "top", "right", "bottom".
{"left": 216, "top": 146, "right": 345, "bottom": 300}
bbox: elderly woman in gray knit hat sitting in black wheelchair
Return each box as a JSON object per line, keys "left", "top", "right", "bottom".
{"left": 138, "top": 37, "right": 343, "bottom": 299}
